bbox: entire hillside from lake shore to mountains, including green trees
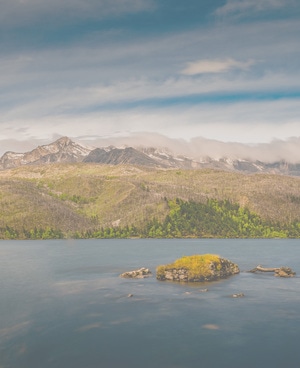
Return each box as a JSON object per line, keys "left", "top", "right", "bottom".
{"left": 0, "top": 163, "right": 300, "bottom": 238}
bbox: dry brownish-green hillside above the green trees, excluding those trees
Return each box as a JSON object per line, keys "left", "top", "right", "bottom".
{"left": 0, "top": 164, "right": 300, "bottom": 231}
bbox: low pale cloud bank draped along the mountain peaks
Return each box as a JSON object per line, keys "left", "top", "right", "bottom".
{"left": 0, "top": 132, "right": 300, "bottom": 164}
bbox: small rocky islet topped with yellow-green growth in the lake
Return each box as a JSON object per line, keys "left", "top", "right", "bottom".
{"left": 156, "top": 254, "right": 240, "bottom": 282}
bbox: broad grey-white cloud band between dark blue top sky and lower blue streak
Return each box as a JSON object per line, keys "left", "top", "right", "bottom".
{"left": 0, "top": 16, "right": 300, "bottom": 106}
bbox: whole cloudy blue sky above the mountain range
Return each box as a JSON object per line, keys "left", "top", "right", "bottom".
{"left": 0, "top": 0, "right": 300, "bottom": 162}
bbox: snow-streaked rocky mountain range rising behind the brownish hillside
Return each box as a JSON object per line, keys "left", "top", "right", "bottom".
{"left": 0, "top": 137, "right": 300, "bottom": 176}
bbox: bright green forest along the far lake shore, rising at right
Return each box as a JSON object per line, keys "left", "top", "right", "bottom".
{"left": 0, "top": 198, "right": 300, "bottom": 239}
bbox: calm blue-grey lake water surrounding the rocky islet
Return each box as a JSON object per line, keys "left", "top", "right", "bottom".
{"left": 0, "top": 239, "right": 300, "bottom": 368}
